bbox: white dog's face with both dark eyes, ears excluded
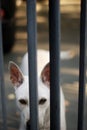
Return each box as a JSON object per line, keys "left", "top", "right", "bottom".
{"left": 15, "top": 77, "right": 50, "bottom": 127}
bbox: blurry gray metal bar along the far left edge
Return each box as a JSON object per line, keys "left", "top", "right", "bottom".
{"left": 0, "top": 0, "right": 7, "bottom": 130}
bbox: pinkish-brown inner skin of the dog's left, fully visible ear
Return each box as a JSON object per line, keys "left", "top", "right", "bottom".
{"left": 10, "top": 65, "right": 23, "bottom": 86}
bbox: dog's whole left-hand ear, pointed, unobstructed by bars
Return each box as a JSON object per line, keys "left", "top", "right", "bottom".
{"left": 9, "top": 61, "right": 24, "bottom": 87}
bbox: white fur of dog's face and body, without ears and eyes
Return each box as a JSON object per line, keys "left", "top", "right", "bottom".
{"left": 9, "top": 50, "right": 66, "bottom": 130}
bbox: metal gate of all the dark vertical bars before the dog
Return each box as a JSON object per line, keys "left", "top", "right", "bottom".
{"left": 0, "top": 0, "right": 87, "bottom": 130}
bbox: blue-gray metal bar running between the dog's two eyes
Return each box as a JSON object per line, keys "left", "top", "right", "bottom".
{"left": 27, "top": 0, "right": 38, "bottom": 130}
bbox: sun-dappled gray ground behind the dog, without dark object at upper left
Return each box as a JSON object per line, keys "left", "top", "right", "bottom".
{"left": 0, "top": 0, "right": 87, "bottom": 130}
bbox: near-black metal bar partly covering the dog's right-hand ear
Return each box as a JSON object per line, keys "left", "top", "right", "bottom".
{"left": 49, "top": 0, "right": 60, "bottom": 130}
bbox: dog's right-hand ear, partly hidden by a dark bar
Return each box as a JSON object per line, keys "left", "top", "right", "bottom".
{"left": 41, "top": 63, "right": 50, "bottom": 87}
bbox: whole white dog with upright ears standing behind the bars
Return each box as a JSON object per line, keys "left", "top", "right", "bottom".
{"left": 9, "top": 50, "right": 68, "bottom": 130}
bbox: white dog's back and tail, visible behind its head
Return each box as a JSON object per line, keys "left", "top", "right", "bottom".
{"left": 20, "top": 49, "right": 72, "bottom": 75}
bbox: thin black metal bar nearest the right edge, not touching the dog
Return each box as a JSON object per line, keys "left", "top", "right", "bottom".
{"left": 78, "top": 0, "right": 87, "bottom": 130}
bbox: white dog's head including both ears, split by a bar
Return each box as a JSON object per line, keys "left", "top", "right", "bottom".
{"left": 9, "top": 62, "right": 50, "bottom": 127}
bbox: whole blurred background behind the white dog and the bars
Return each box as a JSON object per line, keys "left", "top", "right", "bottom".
{"left": 0, "top": 0, "right": 87, "bottom": 130}
